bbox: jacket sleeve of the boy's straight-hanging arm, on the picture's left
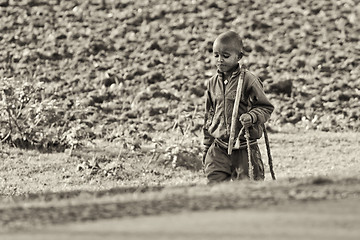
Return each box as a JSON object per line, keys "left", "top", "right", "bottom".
{"left": 203, "top": 85, "right": 214, "bottom": 149}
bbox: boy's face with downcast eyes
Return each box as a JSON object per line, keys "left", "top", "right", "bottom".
{"left": 213, "top": 40, "right": 240, "bottom": 72}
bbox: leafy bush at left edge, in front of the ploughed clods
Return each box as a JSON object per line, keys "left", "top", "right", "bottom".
{"left": 0, "top": 78, "right": 63, "bottom": 149}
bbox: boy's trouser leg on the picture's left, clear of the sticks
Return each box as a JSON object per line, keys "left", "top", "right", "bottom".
{"left": 205, "top": 143, "right": 231, "bottom": 183}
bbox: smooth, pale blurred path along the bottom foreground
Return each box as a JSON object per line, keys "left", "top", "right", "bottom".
{"left": 0, "top": 199, "right": 360, "bottom": 240}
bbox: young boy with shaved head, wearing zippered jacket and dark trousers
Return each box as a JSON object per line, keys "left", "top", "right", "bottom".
{"left": 203, "top": 31, "right": 274, "bottom": 183}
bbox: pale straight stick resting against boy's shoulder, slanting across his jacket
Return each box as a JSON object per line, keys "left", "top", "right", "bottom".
{"left": 228, "top": 66, "right": 245, "bottom": 155}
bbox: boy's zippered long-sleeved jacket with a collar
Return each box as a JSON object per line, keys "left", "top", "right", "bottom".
{"left": 203, "top": 65, "right": 274, "bottom": 148}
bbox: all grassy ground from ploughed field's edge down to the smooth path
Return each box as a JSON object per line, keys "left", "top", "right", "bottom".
{"left": 0, "top": 129, "right": 360, "bottom": 231}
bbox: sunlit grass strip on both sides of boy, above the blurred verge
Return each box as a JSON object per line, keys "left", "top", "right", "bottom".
{"left": 0, "top": 129, "right": 360, "bottom": 195}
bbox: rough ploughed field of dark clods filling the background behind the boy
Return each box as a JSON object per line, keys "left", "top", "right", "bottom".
{"left": 0, "top": 0, "right": 360, "bottom": 150}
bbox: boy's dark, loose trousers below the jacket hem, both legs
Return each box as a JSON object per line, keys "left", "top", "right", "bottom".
{"left": 205, "top": 142, "right": 265, "bottom": 183}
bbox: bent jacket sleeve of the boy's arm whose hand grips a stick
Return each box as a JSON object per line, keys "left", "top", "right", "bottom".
{"left": 247, "top": 75, "right": 274, "bottom": 125}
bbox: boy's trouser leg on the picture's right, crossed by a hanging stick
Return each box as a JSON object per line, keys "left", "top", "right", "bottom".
{"left": 231, "top": 144, "right": 265, "bottom": 180}
